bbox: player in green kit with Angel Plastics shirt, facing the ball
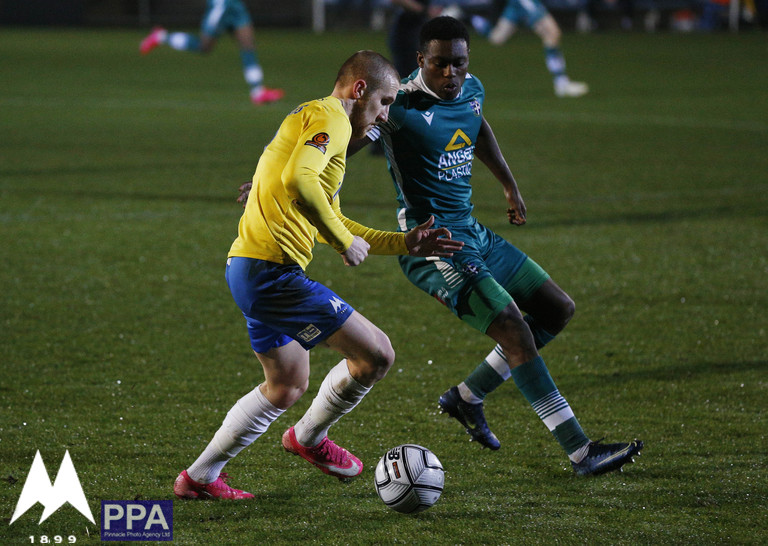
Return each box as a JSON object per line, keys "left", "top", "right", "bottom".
{"left": 348, "top": 17, "right": 643, "bottom": 475}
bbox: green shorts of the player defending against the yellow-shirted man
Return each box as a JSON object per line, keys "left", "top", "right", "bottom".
{"left": 398, "top": 221, "right": 549, "bottom": 333}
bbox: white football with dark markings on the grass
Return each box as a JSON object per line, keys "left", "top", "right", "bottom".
{"left": 374, "top": 444, "right": 445, "bottom": 514}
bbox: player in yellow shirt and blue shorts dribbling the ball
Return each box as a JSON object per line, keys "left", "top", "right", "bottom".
{"left": 174, "top": 51, "right": 463, "bottom": 499}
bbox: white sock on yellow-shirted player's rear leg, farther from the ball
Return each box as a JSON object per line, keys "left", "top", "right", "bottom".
{"left": 187, "top": 387, "right": 285, "bottom": 483}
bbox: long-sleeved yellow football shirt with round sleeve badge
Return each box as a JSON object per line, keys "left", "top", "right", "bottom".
{"left": 229, "top": 97, "right": 408, "bottom": 269}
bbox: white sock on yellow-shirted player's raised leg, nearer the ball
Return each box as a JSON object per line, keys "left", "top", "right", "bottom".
{"left": 293, "top": 359, "right": 371, "bottom": 447}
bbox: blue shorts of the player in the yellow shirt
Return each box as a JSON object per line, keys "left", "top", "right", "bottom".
{"left": 226, "top": 257, "right": 354, "bottom": 353}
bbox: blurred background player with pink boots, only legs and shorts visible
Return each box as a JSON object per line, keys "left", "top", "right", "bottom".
{"left": 139, "top": 0, "right": 285, "bottom": 104}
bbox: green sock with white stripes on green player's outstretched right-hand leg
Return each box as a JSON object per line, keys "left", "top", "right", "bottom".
{"left": 512, "top": 356, "right": 589, "bottom": 455}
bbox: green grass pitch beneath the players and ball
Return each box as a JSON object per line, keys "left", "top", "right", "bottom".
{"left": 0, "top": 29, "right": 768, "bottom": 544}
